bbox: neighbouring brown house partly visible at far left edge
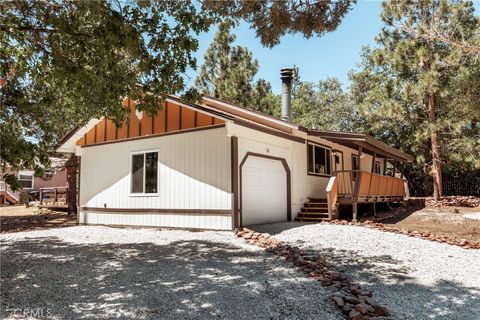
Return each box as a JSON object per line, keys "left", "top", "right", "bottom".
{"left": 0, "top": 157, "right": 67, "bottom": 204}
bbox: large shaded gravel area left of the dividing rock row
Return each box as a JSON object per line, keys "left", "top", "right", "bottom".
{"left": 0, "top": 226, "right": 341, "bottom": 320}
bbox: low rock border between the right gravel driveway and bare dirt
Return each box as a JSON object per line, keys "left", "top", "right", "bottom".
{"left": 320, "top": 220, "right": 480, "bottom": 249}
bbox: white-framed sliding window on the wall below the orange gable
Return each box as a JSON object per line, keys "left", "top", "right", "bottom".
{"left": 131, "top": 152, "right": 158, "bottom": 194}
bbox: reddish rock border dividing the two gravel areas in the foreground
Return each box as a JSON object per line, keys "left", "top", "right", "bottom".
{"left": 235, "top": 228, "right": 390, "bottom": 320}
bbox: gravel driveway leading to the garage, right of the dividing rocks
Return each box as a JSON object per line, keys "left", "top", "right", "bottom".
{"left": 254, "top": 222, "right": 480, "bottom": 320}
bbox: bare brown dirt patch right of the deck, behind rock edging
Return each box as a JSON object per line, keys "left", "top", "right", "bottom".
{"left": 374, "top": 204, "right": 480, "bottom": 242}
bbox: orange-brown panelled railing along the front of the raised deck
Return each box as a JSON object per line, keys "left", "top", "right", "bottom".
{"left": 336, "top": 170, "right": 405, "bottom": 201}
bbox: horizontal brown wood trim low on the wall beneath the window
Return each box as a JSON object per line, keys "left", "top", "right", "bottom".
{"left": 81, "top": 207, "right": 232, "bottom": 216}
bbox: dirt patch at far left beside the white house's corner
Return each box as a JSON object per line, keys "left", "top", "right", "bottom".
{"left": 0, "top": 206, "right": 77, "bottom": 233}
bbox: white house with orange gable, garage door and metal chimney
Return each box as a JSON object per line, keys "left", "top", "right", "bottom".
{"left": 57, "top": 68, "right": 412, "bottom": 229}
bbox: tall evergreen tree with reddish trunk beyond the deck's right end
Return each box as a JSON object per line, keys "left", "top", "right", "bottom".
{"left": 351, "top": 0, "right": 480, "bottom": 198}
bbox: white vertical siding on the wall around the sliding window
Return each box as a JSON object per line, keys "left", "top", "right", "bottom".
{"left": 80, "top": 128, "right": 232, "bottom": 229}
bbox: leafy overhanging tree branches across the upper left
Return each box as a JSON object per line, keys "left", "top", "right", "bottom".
{"left": 0, "top": 0, "right": 351, "bottom": 180}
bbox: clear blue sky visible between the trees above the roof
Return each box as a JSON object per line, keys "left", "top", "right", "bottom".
{"left": 190, "top": 1, "right": 480, "bottom": 93}
